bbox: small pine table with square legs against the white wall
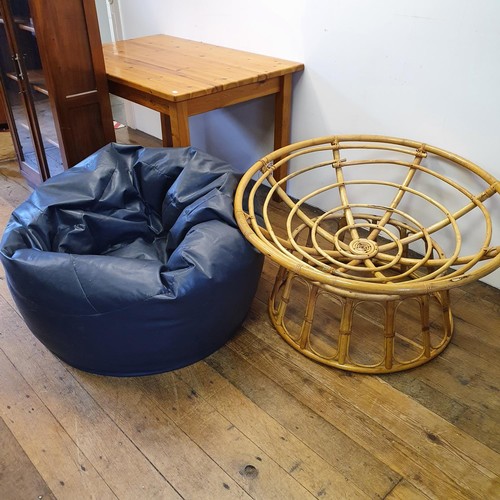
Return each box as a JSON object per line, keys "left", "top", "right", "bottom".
{"left": 103, "top": 35, "right": 304, "bottom": 180}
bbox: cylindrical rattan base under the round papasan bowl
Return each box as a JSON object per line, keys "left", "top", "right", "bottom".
{"left": 269, "top": 267, "right": 453, "bottom": 374}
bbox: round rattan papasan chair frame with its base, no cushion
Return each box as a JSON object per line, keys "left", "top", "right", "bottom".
{"left": 235, "top": 135, "right": 500, "bottom": 373}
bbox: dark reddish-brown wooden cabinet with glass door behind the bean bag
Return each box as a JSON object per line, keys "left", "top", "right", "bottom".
{"left": 0, "top": 0, "right": 115, "bottom": 185}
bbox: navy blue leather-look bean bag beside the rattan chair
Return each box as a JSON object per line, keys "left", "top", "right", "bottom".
{"left": 0, "top": 144, "right": 263, "bottom": 376}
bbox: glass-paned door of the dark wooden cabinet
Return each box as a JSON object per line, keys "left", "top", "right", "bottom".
{"left": 0, "top": 0, "right": 63, "bottom": 184}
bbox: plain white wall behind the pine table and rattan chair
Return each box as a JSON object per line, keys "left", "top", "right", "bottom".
{"left": 115, "top": 0, "right": 500, "bottom": 288}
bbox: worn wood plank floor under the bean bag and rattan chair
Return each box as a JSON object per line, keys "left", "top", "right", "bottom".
{"left": 0, "top": 131, "right": 500, "bottom": 500}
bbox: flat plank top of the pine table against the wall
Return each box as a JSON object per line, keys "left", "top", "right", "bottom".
{"left": 103, "top": 35, "right": 304, "bottom": 102}
